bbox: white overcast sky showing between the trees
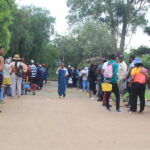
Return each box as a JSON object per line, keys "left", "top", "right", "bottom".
{"left": 16, "top": 0, "right": 150, "bottom": 49}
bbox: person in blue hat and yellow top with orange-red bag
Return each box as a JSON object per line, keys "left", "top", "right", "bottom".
{"left": 131, "top": 58, "right": 148, "bottom": 113}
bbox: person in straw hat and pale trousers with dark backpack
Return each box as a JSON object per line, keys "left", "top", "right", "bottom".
{"left": 9, "top": 54, "right": 27, "bottom": 97}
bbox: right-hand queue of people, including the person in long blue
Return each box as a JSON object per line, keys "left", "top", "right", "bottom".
{"left": 57, "top": 55, "right": 149, "bottom": 113}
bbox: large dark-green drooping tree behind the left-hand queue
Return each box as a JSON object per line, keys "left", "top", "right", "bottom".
{"left": 8, "top": 6, "right": 57, "bottom": 65}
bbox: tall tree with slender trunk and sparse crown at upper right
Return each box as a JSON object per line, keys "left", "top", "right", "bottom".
{"left": 67, "top": 0, "right": 150, "bottom": 53}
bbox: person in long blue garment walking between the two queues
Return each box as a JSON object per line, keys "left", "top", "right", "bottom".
{"left": 56, "top": 63, "right": 68, "bottom": 98}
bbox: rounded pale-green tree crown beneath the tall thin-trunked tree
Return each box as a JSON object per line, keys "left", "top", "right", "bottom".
{"left": 75, "top": 21, "right": 115, "bottom": 58}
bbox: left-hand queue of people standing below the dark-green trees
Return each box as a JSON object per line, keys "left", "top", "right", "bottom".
{"left": 0, "top": 47, "right": 48, "bottom": 112}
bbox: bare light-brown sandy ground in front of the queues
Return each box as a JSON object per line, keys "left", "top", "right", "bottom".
{"left": 0, "top": 82, "right": 150, "bottom": 150}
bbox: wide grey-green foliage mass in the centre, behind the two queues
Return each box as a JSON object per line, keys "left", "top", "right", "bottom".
{"left": 55, "top": 21, "right": 115, "bottom": 66}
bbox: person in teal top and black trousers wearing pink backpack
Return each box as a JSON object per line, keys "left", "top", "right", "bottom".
{"left": 103, "top": 54, "right": 120, "bottom": 112}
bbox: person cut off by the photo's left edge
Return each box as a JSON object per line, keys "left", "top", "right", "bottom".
{"left": 0, "top": 46, "right": 4, "bottom": 112}
